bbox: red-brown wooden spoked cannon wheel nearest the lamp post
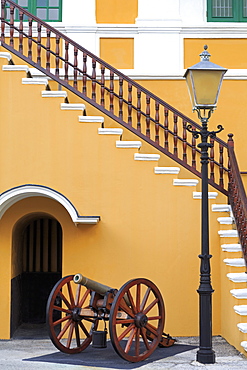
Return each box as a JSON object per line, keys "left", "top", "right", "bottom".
{"left": 109, "top": 279, "right": 165, "bottom": 362}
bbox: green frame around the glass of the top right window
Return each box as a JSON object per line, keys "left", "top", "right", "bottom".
{"left": 207, "top": 0, "right": 247, "bottom": 22}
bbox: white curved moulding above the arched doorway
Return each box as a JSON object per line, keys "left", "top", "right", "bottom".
{"left": 0, "top": 184, "right": 100, "bottom": 225}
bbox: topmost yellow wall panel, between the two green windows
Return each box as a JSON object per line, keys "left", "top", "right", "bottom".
{"left": 96, "top": 0, "right": 138, "bottom": 24}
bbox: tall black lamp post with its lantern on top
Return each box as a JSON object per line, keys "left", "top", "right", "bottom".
{"left": 184, "top": 45, "right": 227, "bottom": 364}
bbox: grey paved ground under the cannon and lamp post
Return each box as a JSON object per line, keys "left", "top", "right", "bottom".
{"left": 0, "top": 337, "right": 247, "bottom": 370}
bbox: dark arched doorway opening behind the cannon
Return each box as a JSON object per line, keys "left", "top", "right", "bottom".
{"left": 11, "top": 214, "right": 62, "bottom": 336}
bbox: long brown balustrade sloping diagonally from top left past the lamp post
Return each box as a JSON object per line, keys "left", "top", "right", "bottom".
{"left": 1, "top": 0, "right": 228, "bottom": 194}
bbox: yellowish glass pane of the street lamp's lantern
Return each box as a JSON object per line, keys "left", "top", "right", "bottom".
{"left": 192, "top": 70, "right": 223, "bottom": 105}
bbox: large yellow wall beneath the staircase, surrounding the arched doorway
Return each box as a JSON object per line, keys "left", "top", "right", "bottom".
{"left": 0, "top": 56, "right": 226, "bottom": 338}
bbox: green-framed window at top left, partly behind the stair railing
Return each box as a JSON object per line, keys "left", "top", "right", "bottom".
{"left": 7, "top": 0, "right": 62, "bottom": 22}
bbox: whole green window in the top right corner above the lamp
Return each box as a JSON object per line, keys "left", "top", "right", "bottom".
{"left": 207, "top": 0, "right": 247, "bottom": 22}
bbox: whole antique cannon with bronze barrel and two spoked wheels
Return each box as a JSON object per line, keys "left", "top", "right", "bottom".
{"left": 47, "top": 274, "right": 175, "bottom": 362}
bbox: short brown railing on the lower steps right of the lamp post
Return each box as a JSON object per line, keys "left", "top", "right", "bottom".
{"left": 228, "top": 134, "right": 247, "bottom": 266}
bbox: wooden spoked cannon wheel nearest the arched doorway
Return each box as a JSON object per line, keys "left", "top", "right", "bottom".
{"left": 46, "top": 275, "right": 97, "bottom": 354}
